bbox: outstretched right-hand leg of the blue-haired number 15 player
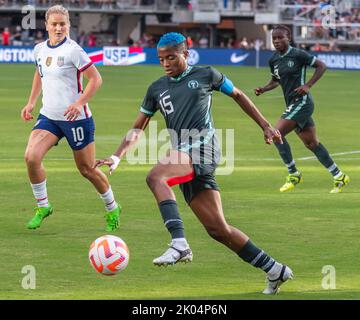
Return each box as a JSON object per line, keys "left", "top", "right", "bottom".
{"left": 190, "top": 189, "right": 293, "bottom": 294}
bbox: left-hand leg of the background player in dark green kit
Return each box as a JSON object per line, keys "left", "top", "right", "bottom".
{"left": 274, "top": 118, "right": 302, "bottom": 192}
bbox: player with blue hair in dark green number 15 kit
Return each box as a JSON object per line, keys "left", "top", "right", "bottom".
{"left": 97, "top": 33, "right": 293, "bottom": 294}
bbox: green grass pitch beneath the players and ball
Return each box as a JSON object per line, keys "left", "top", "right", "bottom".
{"left": 0, "top": 65, "right": 360, "bottom": 300}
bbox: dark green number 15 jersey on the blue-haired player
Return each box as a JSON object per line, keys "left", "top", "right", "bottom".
{"left": 140, "top": 67, "right": 225, "bottom": 166}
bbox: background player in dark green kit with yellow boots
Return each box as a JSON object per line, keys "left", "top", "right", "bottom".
{"left": 255, "top": 25, "right": 350, "bottom": 193}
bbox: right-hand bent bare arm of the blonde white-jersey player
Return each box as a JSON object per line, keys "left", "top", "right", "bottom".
{"left": 64, "top": 65, "right": 102, "bottom": 121}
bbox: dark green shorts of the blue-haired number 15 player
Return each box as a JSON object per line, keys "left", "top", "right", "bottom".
{"left": 180, "top": 164, "right": 220, "bottom": 205}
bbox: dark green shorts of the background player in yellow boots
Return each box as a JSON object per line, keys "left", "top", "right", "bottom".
{"left": 281, "top": 99, "right": 315, "bottom": 133}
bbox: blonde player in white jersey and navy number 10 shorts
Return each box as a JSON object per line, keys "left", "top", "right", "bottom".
{"left": 21, "top": 5, "right": 121, "bottom": 231}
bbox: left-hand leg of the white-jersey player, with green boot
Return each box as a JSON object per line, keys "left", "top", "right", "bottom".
{"left": 24, "top": 129, "right": 59, "bottom": 229}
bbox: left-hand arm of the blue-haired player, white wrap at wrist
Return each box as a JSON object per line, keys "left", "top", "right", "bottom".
{"left": 95, "top": 112, "right": 151, "bottom": 174}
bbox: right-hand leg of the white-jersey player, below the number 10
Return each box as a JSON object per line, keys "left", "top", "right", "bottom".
{"left": 73, "top": 141, "right": 121, "bottom": 231}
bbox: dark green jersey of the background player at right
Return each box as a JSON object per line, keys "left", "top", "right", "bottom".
{"left": 269, "top": 46, "right": 316, "bottom": 106}
